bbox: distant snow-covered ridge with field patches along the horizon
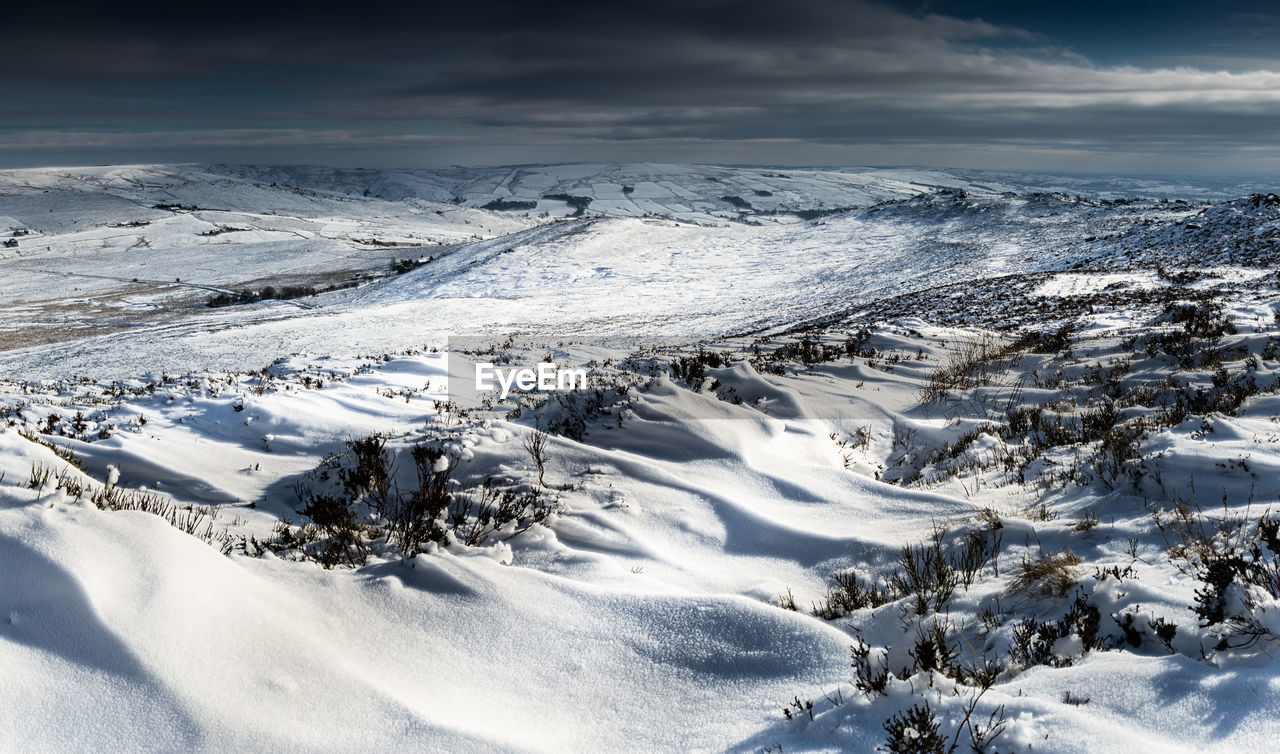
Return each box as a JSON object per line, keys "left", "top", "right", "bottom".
{"left": 0, "top": 163, "right": 1270, "bottom": 231}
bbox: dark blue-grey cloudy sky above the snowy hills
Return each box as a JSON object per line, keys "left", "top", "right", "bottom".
{"left": 0, "top": 0, "right": 1280, "bottom": 174}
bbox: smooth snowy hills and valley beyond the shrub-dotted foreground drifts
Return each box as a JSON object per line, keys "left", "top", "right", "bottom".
{"left": 0, "top": 165, "right": 1228, "bottom": 378}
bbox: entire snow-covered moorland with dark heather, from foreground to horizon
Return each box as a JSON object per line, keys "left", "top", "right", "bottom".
{"left": 0, "top": 165, "right": 1280, "bottom": 751}
